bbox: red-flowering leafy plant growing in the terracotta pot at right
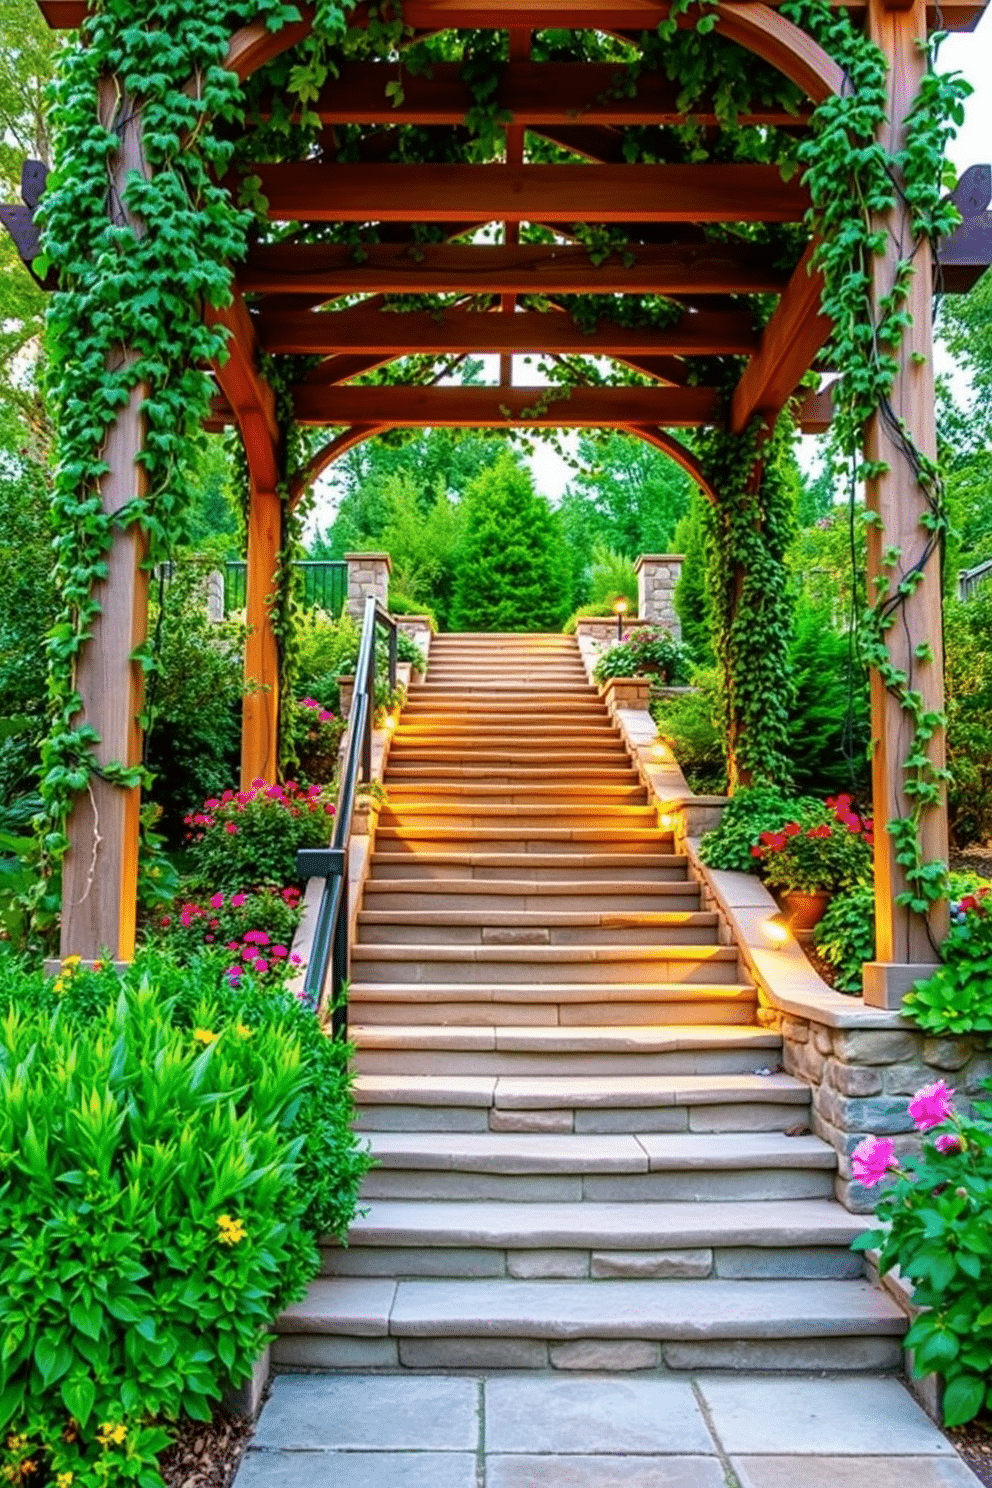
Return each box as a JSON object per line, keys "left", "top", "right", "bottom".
{"left": 751, "top": 796, "right": 875, "bottom": 894}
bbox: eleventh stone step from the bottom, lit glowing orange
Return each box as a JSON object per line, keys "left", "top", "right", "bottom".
{"left": 376, "top": 821, "right": 672, "bottom": 857}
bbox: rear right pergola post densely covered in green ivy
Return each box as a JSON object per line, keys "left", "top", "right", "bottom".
{"left": 699, "top": 418, "right": 794, "bottom": 790}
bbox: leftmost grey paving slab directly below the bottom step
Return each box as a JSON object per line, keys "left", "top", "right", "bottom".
{"left": 254, "top": 1375, "right": 479, "bottom": 1452}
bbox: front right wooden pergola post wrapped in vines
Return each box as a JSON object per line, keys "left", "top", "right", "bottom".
{"left": 864, "top": 0, "right": 947, "bottom": 1007}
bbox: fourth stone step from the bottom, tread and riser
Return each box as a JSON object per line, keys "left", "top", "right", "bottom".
{"left": 354, "top": 1073, "right": 809, "bottom": 1134}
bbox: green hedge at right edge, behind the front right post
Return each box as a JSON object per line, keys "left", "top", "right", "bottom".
{"left": 944, "top": 585, "right": 992, "bottom": 847}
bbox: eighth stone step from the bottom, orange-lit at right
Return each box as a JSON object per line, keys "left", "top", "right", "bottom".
{"left": 358, "top": 902, "right": 720, "bottom": 945}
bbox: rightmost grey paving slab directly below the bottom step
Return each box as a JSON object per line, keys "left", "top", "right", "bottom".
{"left": 699, "top": 1378, "right": 955, "bottom": 1458}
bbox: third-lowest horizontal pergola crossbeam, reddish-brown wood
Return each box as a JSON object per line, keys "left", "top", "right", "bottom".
{"left": 238, "top": 241, "right": 788, "bottom": 299}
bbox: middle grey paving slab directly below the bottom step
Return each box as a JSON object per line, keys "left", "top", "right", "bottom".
{"left": 485, "top": 1376, "right": 712, "bottom": 1457}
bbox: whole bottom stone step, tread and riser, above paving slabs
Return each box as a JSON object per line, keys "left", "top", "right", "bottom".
{"left": 274, "top": 1277, "right": 907, "bottom": 1370}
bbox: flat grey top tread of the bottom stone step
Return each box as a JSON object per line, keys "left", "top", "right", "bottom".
{"left": 275, "top": 1278, "right": 907, "bottom": 1339}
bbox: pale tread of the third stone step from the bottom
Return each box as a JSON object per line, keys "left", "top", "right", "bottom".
{"left": 364, "top": 1131, "right": 837, "bottom": 1174}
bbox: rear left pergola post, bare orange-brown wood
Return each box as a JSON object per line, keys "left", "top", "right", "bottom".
{"left": 241, "top": 476, "right": 283, "bottom": 790}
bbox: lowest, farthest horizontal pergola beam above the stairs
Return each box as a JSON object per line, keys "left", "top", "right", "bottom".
{"left": 293, "top": 383, "right": 720, "bottom": 429}
